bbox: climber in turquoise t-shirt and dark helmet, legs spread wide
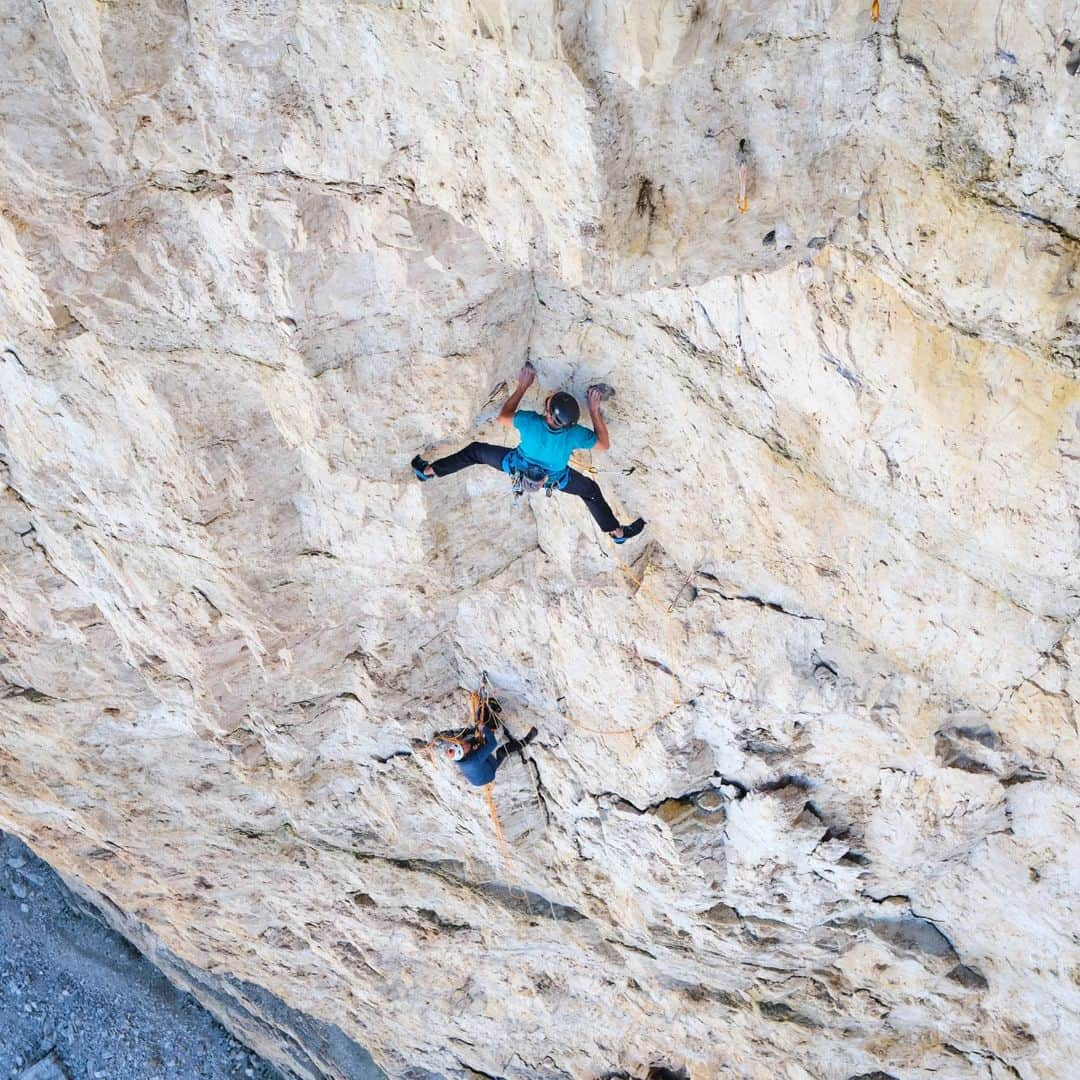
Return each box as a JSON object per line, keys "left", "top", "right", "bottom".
{"left": 411, "top": 363, "right": 645, "bottom": 543}
